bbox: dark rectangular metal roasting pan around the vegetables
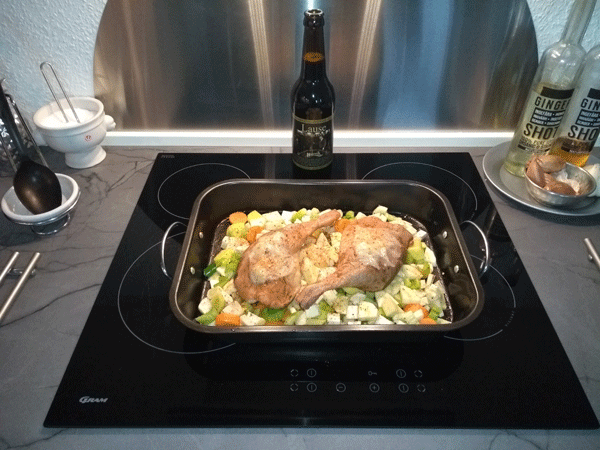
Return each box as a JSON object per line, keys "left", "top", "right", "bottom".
{"left": 169, "top": 179, "right": 484, "bottom": 342}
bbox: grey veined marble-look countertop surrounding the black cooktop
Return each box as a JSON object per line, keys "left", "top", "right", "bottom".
{"left": 0, "top": 147, "right": 600, "bottom": 450}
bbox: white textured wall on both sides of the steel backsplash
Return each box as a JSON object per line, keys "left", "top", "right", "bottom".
{"left": 0, "top": 0, "right": 600, "bottom": 126}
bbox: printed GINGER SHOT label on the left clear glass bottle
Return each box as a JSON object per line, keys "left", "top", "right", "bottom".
{"left": 517, "top": 86, "right": 573, "bottom": 154}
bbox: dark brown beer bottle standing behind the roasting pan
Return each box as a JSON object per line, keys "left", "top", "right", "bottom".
{"left": 292, "top": 9, "right": 335, "bottom": 170}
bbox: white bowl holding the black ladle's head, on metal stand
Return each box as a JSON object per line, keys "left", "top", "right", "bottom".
{"left": 2, "top": 173, "right": 80, "bottom": 234}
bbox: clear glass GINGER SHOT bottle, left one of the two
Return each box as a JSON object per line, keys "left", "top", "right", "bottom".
{"left": 503, "top": 0, "right": 596, "bottom": 177}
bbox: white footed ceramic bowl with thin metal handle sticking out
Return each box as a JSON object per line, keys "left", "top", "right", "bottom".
{"left": 33, "top": 97, "right": 115, "bottom": 169}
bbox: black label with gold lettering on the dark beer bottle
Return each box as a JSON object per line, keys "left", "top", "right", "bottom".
{"left": 292, "top": 115, "right": 333, "bottom": 169}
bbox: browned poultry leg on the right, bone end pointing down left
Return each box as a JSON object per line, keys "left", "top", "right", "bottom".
{"left": 295, "top": 217, "right": 412, "bottom": 309}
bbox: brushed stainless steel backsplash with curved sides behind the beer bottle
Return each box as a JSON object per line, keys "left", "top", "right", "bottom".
{"left": 94, "top": 0, "right": 538, "bottom": 130}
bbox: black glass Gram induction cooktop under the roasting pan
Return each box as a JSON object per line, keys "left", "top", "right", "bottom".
{"left": 44, "top": 153, "right": 599, "bottom": 429}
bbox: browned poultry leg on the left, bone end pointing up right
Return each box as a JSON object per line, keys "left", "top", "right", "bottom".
{"left": 234, "top": 210, "right": 340, "bottom": 308}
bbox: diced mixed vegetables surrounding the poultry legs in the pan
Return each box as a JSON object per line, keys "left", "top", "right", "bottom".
{"left": 196, "top": 206, "right": 449, "bottom": 326}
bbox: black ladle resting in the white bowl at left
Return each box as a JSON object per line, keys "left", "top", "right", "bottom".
{"left": 0, "top": 84, "right": 62, "bottom": 214}
